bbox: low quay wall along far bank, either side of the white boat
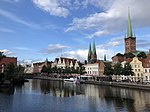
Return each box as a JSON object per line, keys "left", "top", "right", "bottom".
{"left": 30, "top": 76, "right": 150, "bottom": 91}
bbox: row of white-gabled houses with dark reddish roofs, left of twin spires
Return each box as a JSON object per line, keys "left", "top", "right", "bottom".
{"left": 52, "top": 57, "right": 81, "bottom": 69}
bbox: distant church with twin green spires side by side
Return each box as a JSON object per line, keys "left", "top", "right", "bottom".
{"left": 88, "top": 42, "right": 97, "bottom": 63}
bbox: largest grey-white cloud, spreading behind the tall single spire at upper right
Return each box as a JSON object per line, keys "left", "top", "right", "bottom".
{"left": 66, "top": 0, "right": 150, "bottom": 38}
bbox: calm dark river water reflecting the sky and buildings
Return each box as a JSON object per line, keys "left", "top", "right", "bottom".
{"left": 0, "top": 79, "right": 150, "bottom": 112}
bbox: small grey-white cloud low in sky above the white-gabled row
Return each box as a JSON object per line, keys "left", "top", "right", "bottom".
{"left": 41, "top": 44, "right": 68, "bottom": 54}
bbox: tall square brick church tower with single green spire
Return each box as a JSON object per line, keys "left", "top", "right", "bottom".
{"left": 124, "top": 11, "right": 136, "bottom": 53}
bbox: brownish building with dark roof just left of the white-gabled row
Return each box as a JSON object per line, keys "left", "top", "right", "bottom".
{"left": 33, "top": 59, "right": 52, "bottom": 73}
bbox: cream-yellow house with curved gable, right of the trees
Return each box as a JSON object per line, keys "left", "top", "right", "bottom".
{"left": 130, "top": 57, "right": 144, "bottom": 82}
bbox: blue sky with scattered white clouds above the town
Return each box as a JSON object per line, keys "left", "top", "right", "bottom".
{"left": 0, "top": 0, "right": 150, "bottom": 63}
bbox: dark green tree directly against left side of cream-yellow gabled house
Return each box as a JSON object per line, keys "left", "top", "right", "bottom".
{"left": 122, "top": 63, "right": 134, "bottom": 76}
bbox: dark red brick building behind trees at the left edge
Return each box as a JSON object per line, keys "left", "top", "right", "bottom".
{"left": 0, "top": 57, "right": 17, "bottom": 73}
